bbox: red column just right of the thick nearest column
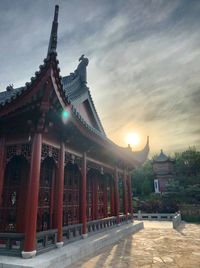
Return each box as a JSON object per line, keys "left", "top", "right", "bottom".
{"left": 56, "top": 142, "right": 65, "bottom": 248}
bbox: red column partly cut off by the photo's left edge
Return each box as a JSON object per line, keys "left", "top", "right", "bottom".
{"left": 0, "top": 137, "right": 6, "bottom": 206}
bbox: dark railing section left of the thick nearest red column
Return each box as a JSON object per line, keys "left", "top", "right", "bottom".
{"left": 0, "top": 233, "right": 24, "bottom": 256}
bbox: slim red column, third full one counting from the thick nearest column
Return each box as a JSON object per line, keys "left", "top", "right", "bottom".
{"left": 81, "top": 153, "right": 87, "bottom": 238}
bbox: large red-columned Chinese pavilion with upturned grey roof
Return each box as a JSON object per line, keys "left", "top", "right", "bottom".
{"left": 0, "top": 6, "right": 149, "bottom": 258}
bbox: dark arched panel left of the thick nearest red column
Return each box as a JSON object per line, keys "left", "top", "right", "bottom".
{"left": 0, "top": 156, "right": 29, "bottom": 232}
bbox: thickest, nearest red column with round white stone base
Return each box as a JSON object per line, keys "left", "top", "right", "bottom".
{"left": 22, "top": 133, "right": 42, "bottom": 258}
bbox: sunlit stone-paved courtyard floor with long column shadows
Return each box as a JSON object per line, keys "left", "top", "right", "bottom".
{"left": 68, "top": 221, "right": 200, "bottom": 268}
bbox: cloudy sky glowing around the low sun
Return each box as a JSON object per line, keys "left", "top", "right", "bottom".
{"left": 0, "top": 0, "right": 200, "bottom": 155}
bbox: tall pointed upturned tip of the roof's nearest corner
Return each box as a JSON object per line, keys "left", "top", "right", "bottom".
{"left": 47, "top": 5, "right": 59, "bottom": 56}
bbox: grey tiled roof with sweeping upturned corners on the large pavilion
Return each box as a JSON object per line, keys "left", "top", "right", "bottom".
{"left": 0, "top": 6, "right": 149, "bottom": 166}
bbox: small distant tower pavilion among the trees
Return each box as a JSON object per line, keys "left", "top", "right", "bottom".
{"left": 153, "top": 150, "right": 174, "bottom": 193}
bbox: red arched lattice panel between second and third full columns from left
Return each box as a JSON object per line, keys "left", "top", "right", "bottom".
{"left": 63, "top": 162, "right": 81, "bottom": 226}
